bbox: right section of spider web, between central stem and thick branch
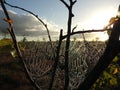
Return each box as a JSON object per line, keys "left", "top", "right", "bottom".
{"left": 69, "top": 38, "right": 105, "bottom": 90}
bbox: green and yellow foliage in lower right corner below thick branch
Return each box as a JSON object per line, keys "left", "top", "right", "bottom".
{"left": 91, "top": 56, "right": 120, "bottom": 90}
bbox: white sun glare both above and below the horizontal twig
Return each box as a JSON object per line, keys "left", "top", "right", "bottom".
{"left": 81, "top": 8, "right": 116, "bottom": 41}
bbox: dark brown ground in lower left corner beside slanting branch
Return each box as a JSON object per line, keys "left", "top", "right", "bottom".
{"left": 0, "top": 51, "right": 34, "bottom": 90}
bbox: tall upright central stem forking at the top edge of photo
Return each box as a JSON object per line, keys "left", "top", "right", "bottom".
{"left": 60, "top": 0, "right": 76, "bottom": 90}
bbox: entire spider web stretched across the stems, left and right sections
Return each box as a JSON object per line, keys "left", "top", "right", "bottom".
{"left": 20, "top": 36, "right": 106, "bottom": 90}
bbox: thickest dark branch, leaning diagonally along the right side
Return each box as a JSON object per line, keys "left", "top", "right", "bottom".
{"left": 77, "top": 18, "right": 120, "bottom": 90}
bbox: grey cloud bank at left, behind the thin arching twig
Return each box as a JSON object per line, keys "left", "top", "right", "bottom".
{"left": 0, "top": 9, "right": 59, "bottom": 36}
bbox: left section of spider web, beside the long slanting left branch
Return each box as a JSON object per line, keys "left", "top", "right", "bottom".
{"left": 23, "top": 41, "right": 54, "bottom": 90}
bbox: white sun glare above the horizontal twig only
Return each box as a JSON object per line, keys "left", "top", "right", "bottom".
{"left": 88, "top": 9, "right": 116, "bottom": 29}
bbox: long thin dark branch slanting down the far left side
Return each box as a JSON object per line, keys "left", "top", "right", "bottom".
{"left": 0, "top": 0, "right": 40, "bottom": 90}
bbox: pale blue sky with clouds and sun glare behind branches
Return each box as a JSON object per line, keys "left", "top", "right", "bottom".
{"left": 0, "top": 0, "right": 120, "bottom": 39}
